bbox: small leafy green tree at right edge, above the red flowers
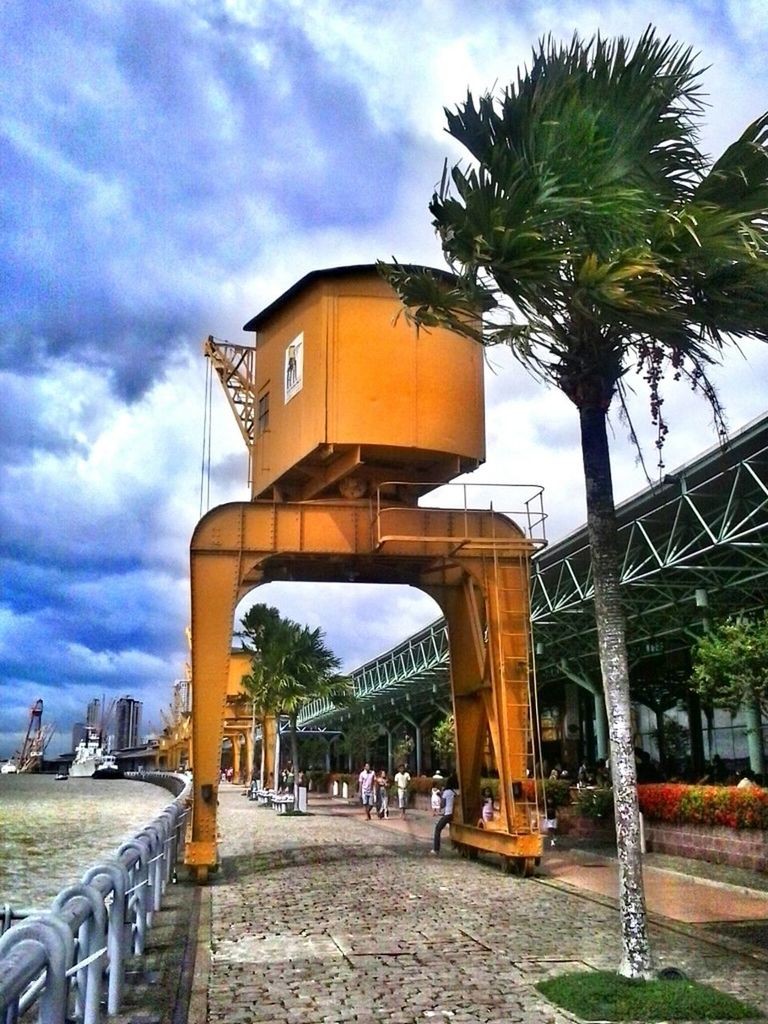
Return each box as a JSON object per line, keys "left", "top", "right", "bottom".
{"left": 691, "top": 611, "right": 768, "bottom": 779}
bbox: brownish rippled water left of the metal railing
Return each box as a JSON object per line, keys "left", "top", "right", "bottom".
{"left": 0, "top": 774, "right": 173, "bottom": 909}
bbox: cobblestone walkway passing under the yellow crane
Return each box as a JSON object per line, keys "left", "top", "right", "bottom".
{"left": 189, "top": 787, "right": 768, "bottom": 1024}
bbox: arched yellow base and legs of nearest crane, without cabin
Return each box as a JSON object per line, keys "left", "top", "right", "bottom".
{"left": 186, "top": 500, "right": 542, "bottom": 881}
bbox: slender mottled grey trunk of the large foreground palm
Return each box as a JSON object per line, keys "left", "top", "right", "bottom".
{"left": 580, "top": 407, "right": 651, "bottom": 978}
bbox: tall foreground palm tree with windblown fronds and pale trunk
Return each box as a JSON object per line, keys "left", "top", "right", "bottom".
{"left": 382, "top": 28, "right": 768, "bottom": 978}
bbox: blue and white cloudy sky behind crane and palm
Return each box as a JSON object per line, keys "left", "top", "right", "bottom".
{"left": 0, "top": 0, "right": 768, "bottom": 756}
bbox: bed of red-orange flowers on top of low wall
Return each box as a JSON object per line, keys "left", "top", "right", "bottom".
{"left": 637, "top": 782, "right": 768, "bottom": 829}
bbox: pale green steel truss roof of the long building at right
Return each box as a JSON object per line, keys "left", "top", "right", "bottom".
{"left": 299, "top": 416, "right": 768, "bottom": 725}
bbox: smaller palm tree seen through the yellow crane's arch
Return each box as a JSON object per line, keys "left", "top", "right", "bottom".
{"left": 241, "top": 604, "right": 349, "bottom": 773}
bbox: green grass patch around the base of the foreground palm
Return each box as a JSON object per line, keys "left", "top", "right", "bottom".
{"left": 536, "top": 971, "right": 763, "bottom": 1024}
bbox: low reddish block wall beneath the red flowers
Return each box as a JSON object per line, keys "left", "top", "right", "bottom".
{"left": 645, "top": 820, "right": 768, "bottom": 871}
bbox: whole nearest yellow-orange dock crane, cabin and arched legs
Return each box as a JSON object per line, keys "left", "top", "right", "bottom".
{"left": 186, "top": 266, "right": 543, "bottom": 882}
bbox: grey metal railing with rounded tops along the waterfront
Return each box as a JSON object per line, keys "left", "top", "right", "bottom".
{"left": 0, "top": 773, "right": 191, "bottom": 1024}
